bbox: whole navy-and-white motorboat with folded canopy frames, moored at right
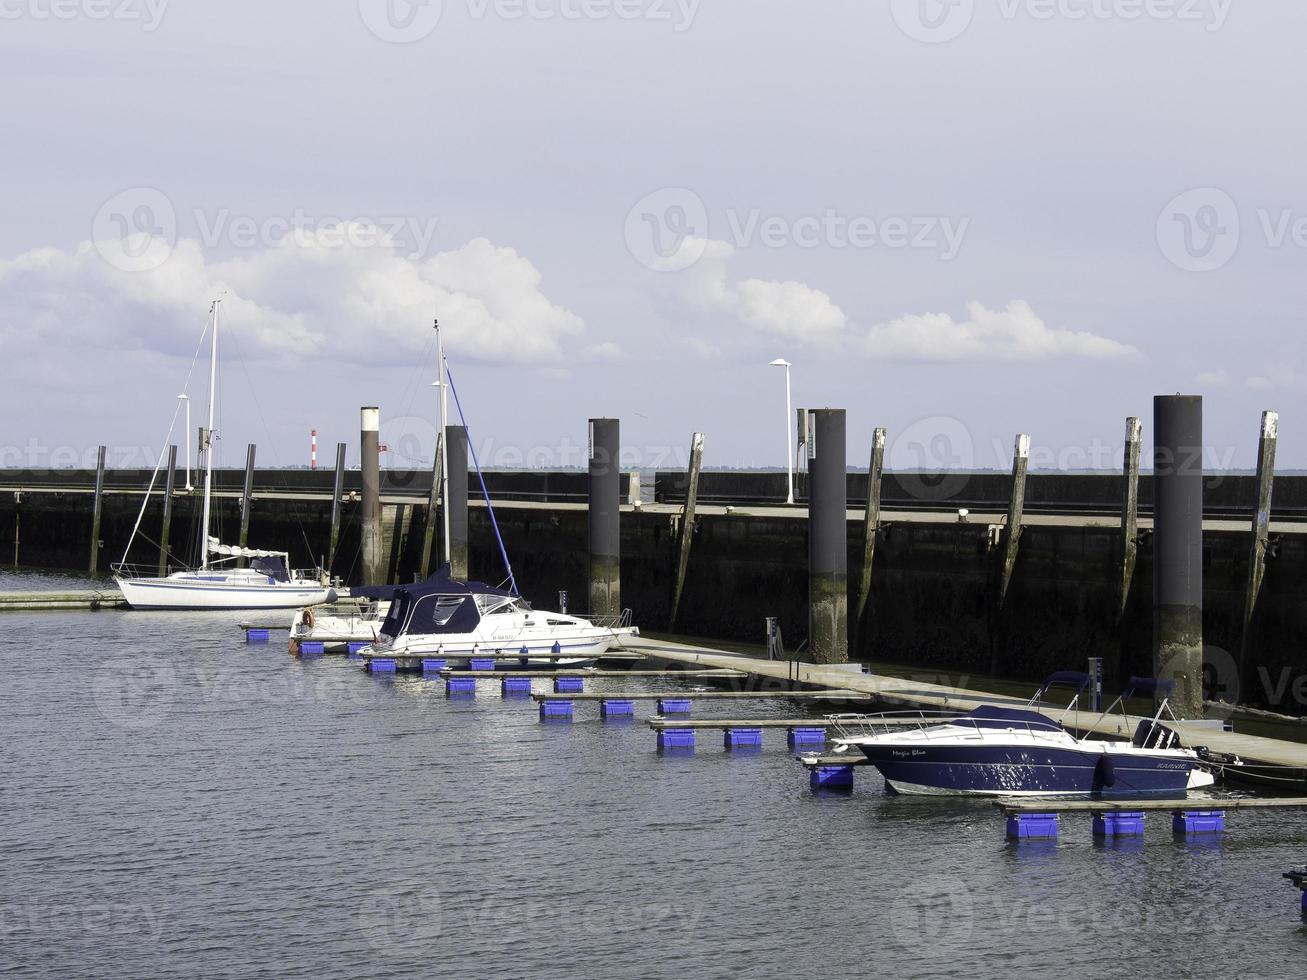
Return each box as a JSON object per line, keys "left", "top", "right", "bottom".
{"left": 830, "top": 672, "right": 1216, "bottom": 798}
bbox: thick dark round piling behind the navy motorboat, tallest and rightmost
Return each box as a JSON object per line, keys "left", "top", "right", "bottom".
{"left": 1153, "top": 395, "right": 1202, "bottom": 719}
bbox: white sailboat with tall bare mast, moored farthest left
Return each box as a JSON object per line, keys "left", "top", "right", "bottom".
{"left": 114, "top": 299, "right": 336, "bottom": 609}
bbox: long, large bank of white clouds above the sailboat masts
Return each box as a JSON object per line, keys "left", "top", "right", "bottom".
{"left": 0, "top": 227, "right": 588, "bottom": 365}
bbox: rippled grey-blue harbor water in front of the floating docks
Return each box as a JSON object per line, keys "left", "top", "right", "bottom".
{"left": 0, "top": 575, "right": 1307, "bottom": 980}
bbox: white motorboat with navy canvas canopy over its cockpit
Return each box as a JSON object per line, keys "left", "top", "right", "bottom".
{"left": 362, "top": 567, "right": 639, "bottom": 670}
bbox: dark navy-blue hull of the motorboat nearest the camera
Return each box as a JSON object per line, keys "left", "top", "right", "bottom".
{"left": 859, "top": 742, "right": 1210, "bottom": 798}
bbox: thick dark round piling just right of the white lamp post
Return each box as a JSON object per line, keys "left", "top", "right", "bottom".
{"left": 808, "top": 409, "right": 848, "bottom": 664}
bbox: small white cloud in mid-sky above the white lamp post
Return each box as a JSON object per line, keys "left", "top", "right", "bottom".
{"left": 668, "top": 238, "right": 848, "bottom": 345}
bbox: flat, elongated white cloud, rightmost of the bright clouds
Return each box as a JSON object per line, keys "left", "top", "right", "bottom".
{"left": 865, "top": 299, "right": 1142, "bottom": 361}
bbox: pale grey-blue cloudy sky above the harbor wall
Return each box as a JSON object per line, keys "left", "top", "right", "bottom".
{"left": 0, "top": 0, "right": 1307, "bottom": 469}
